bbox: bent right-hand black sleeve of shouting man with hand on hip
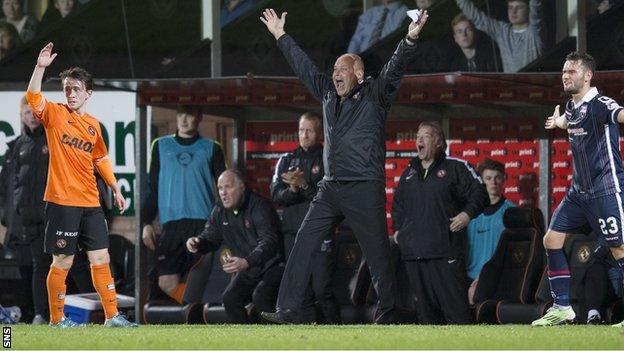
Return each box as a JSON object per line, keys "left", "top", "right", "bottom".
{"left": 455, "top": 161, "right": 490, "bottom": 218}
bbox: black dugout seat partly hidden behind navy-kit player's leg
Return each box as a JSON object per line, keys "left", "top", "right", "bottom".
{"left": 496, "top": 232, "right": 597, "bottom": 324}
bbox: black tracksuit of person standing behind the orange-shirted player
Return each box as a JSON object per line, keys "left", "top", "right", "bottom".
{"left": 13, "top": 126, "right": 94, "bottom": 318}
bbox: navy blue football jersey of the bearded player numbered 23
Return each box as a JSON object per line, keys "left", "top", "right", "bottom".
{"left": 565, "top": 88, "right": 624, "bottom": 198}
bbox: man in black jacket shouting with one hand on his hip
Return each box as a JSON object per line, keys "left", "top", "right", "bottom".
{"left": 392, "top": 122, "right": 489, "bottom": 324}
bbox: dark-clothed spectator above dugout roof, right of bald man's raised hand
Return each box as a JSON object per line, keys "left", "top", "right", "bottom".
{"left": 449, "top": 13, "right": 496, "bottom": 72}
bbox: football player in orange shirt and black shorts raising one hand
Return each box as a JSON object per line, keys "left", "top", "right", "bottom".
{"left": 26, "top": 43, "right": 137, "bottom": 328}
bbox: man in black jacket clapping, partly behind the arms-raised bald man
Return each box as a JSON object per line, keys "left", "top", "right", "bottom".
{"left": 271, "top": 112, "right": 340, "bottom": 324}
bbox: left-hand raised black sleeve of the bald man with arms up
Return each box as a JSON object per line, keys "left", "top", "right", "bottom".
{"left": 277, "top": 34, "right": 332, "bottom": 101}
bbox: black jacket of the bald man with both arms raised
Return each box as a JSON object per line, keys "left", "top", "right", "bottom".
{"left": 277, "top": 34, "right": 416, "bottom": 182}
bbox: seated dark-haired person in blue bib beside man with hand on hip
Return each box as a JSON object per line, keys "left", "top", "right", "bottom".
{"left": 466, "top": 158, "right": 516, "bottom": 305}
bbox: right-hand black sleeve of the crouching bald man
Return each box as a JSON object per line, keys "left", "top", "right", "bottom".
{"left": 245, "top": 201, "right": 279, "bottom": 267}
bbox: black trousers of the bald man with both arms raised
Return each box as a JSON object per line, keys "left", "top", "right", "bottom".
{"left": 277, "top": 181, "right": 395, "bottom": 316}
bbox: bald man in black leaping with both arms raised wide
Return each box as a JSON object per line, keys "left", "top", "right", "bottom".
{"left": 261, "top": 9, "right": 427, "bottom": 323}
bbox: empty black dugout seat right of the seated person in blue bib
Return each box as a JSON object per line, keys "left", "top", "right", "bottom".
{"left": 474, "top": 207, "right": 544, "bottom": 323}
